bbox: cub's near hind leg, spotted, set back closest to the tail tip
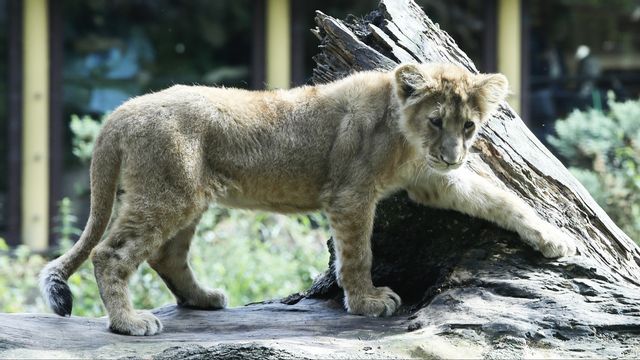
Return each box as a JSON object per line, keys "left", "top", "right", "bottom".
{"left": 92, "top": 198, "right": 201, "bottom": 335}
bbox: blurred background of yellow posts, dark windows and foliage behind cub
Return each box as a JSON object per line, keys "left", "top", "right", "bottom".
{"left": 0, "top": 0, "right": 640, "bottom": 314}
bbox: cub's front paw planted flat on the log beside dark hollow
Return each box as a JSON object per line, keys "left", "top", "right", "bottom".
{"left": 345, "top": 287, "right": 401, "bottom": 316}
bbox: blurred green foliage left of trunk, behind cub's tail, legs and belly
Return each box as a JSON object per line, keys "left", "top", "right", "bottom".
{"left": 0, "top": 117, "right": 329, "bottom": 316}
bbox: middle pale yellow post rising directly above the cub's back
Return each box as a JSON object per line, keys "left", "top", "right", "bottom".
{"left": 266, "top": 0, "right": 291, "bottom": 89}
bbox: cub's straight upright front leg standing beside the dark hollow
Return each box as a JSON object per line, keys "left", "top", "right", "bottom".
{"left": 327, "top": 194, "right": 400, "bottom": 316}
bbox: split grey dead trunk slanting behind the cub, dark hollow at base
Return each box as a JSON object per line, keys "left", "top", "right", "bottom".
{"left": 309, "top": 0, "right": 640, "bottom": 356}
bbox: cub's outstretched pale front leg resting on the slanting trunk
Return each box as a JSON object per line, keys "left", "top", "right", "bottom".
{"left": 408, "top": 169, "right": 576, "bottom": 258}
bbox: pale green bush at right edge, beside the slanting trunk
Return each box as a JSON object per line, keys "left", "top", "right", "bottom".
{"left": 548, "top": 95, "right": 640, "bottom": 242}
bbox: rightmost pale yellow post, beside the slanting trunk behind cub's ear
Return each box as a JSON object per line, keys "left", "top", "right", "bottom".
{"left": 498, "top": 0, "right": 522, "bottom": 113}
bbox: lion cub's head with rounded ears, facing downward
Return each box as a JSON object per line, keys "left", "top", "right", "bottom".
{"left": 394, "top": 64, "right": 508, "bottom": 171}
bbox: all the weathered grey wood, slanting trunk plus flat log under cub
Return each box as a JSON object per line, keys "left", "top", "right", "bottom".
{"left": 0, "top": 0, "right": 640, "bottom": 359}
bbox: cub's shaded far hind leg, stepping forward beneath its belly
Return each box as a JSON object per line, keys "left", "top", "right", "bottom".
{"left": 149, "top": 221, "right": 227, "bottom": 310}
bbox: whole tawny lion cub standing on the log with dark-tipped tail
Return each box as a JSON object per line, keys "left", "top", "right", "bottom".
{"left": 41, "top": 64, "right": 575, "bottom": 335}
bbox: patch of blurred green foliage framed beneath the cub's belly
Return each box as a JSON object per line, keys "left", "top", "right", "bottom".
{"left": 191, "top": 207, "right": 328, "bottom": 306}
